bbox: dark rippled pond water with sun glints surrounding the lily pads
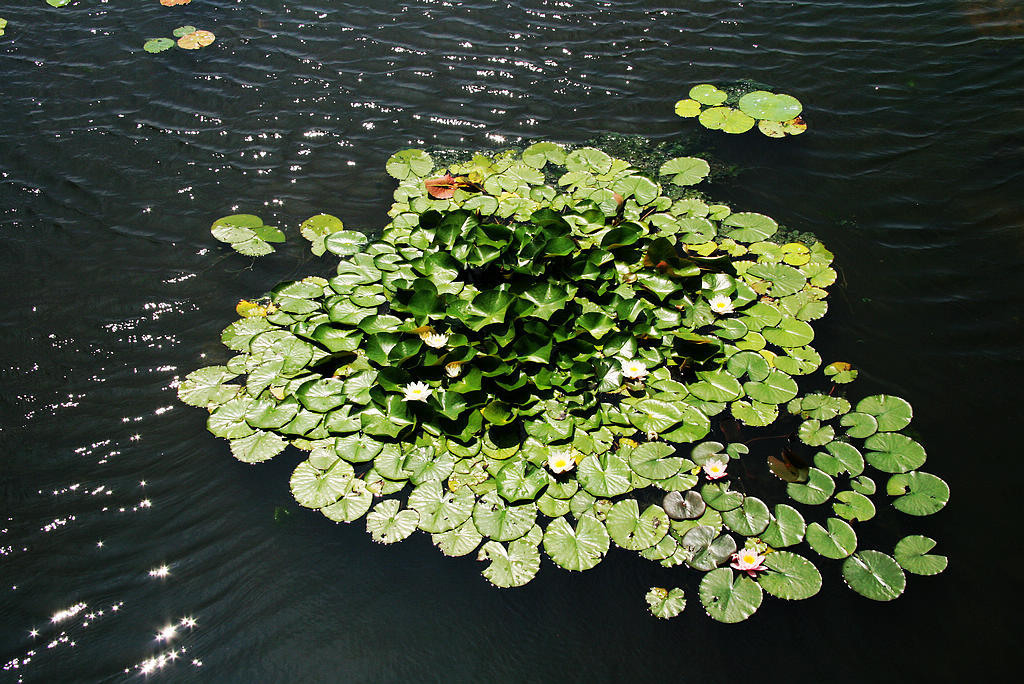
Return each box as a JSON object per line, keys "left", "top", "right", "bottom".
{"left": 0, "top": 0, "right": 1024, "bottom": 683}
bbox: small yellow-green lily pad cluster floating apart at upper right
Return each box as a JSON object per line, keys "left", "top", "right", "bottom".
{"left": 676, "top": 83, "right": 807, "bottom": 138}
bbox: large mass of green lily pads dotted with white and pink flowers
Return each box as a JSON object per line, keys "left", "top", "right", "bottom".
{"left": 178, "top": 142, "right": 948, "bottom": 623}
